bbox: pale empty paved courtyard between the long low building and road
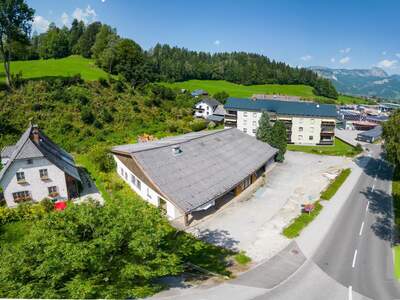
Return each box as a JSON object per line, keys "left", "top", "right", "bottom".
{"left": 188, "top": 151, "right": 351, "bottom": 262}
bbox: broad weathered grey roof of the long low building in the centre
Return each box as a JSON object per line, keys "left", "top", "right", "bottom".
{"left": 113, "top": 128, "right": 277, "bottom": 212}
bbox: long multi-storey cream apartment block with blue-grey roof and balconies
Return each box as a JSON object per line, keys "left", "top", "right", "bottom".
{"left": 224, "top": 98, "right": 337, "bottom": 145}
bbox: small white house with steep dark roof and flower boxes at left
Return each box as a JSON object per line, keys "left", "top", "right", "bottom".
{"left": 0, "top": 125, "right": 81, "bottom": 207}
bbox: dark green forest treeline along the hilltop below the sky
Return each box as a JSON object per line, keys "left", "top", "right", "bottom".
{"left": 7, "top": 20, "right": 338, "bottom": 99}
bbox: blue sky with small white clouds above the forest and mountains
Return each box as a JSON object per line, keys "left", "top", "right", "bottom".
{"left": 27, "top": 0, "right": 400, "bottom": 73}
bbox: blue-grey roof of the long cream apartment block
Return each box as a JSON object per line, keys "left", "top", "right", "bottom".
{"left": 224, "top": 98, "right": 336, "bottom": 118}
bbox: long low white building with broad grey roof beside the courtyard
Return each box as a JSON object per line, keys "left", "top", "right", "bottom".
{"left": 112, "top": 128, "right": 277, "bottom": 225}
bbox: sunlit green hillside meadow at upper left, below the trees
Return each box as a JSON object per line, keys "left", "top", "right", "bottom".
{"left": 0, "top": 55, "right": 108, "bottom": 82}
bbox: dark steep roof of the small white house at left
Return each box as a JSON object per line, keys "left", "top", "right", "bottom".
{"left": 0, "top": 126, "right": 81, "bottom": 181}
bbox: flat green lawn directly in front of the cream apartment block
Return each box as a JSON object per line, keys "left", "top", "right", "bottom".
{"left": 287, "top": 138, "right": 359, "bottom": 157}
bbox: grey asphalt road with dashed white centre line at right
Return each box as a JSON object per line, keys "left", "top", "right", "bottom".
{"left": 313, "top": 146, "right": 400, "bottom": 300}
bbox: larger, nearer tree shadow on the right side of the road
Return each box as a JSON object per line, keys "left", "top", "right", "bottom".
{"left": 361, "top": 188, "right": 393, "bottom": 242}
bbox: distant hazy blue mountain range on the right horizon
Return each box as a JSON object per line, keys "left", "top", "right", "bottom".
{"left": 310, "top": 67, "right": 400, "bottom": 101}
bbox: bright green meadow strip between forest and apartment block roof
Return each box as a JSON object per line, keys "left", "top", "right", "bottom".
{"left": 163, "top": 80, "right": 365, "bottom": 104}
